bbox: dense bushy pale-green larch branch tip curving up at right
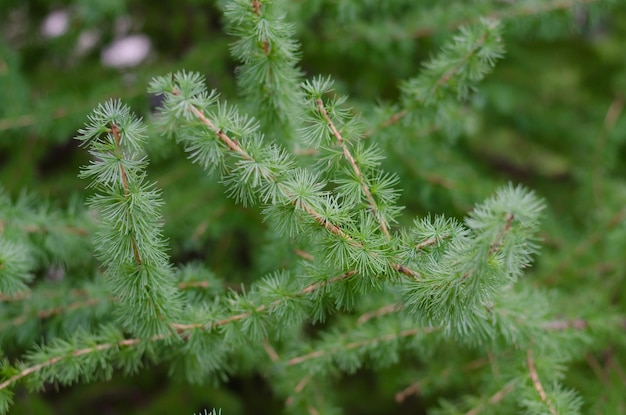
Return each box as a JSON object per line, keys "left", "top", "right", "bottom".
{"left": 404, "top": 186, "right": 543, "bottom": 338}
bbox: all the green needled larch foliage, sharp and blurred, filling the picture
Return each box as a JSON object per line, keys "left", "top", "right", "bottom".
{"left": 0, "top": 0, "right": 626, "bottom": 415}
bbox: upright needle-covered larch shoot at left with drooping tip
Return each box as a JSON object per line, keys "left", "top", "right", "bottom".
{"left": 77, "top": 101, "right": 181, "bottom": 337}
